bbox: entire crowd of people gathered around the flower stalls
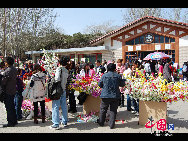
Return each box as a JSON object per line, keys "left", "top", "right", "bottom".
{"left": 0, "top": 57, "right": 182, "bottom": 129}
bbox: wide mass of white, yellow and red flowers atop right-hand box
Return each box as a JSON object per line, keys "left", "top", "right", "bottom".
{"left": 125, "top": 70, "right": 188, "bottom": 102}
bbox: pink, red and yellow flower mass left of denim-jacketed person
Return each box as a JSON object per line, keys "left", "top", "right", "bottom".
{"left": 69, "top": 74, "right": 101, "bottom": 97}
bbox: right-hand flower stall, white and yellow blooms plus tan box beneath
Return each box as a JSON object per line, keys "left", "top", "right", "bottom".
{"left": 125, "top": 70, "right": 188, "bottom": 125}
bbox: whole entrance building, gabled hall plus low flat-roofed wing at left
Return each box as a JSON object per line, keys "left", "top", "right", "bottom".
{"left": 26, "top": 16, "right": 188, "bottom": 67}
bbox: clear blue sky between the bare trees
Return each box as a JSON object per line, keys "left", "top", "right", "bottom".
{"left": 54, "top": 8, "right": 123, "bottom": 35}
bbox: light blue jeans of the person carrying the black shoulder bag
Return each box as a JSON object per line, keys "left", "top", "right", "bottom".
{"left": 52, "top": 91, "right": 68, "bottom": 125}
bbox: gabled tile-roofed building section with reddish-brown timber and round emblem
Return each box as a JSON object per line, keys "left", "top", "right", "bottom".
{"left": 91, "top": 16, "right": 188, "bottom": 66}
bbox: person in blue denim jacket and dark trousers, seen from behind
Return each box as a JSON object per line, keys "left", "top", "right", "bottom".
{"left": 98, "top": 63, "right": 125, "bottom": 129}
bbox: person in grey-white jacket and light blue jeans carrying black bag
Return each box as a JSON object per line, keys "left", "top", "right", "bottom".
{"left": 50, "top": 57, "right": 69, "bottom": 130}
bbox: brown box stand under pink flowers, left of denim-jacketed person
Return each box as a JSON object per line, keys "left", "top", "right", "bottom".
{"left": 83, "top": 95, "right": 101, "bottom": 116}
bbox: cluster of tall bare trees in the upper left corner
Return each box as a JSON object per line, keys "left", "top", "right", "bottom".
{"left": 0, "top": 8, "right": 56, "bottom": 56}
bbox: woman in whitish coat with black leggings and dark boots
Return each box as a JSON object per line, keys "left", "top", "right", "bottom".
{"left": 29, "top": 64, "right": 46, "bottom": 124}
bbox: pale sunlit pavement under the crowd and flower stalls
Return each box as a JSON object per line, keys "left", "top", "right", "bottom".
{"left": 0, "top": 91, "right": 188, "bottom": 133}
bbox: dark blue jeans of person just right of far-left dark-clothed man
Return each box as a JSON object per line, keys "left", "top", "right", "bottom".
{"left": 14, "top": 92, "right": 23, "bottom": 120}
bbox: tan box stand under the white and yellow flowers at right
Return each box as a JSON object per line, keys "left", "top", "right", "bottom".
{"left": 139, "top": 100, "right": 167, "bottom": 126}
